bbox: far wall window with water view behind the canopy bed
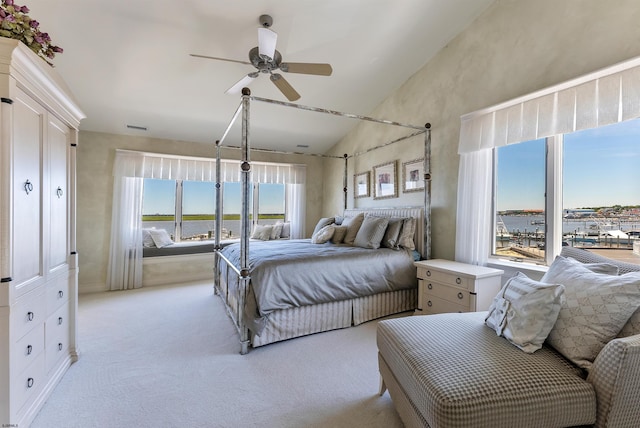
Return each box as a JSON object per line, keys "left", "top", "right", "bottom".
{"left": 142, "top": 178, "right": 286, "bottom": 242}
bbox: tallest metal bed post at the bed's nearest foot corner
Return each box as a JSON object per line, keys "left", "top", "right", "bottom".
{"left": 237, "top": 88, "right": 251, "bottom": 355}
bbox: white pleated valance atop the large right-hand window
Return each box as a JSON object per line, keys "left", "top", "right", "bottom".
{"left": 458, "top": 57, "right": 640, "bottom": 153}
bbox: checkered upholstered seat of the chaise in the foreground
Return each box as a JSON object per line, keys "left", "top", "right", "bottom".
{"left": 377, "top": 312, "right": 596, "bottom": 428}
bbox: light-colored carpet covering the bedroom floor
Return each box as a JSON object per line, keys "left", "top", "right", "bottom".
{"left": 32, "top": 283, "right": 402, "bottom": 428}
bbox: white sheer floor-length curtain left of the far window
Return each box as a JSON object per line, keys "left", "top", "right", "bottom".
{"left": 107, "top": 176, "right": 144, "bottom": 290}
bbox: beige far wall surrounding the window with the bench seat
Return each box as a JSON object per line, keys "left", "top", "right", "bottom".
{"left": 77, "top": 131, "right": 322, "bottom": 293}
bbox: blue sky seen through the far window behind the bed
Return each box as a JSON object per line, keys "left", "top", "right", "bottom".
{"left": 142, "top": 179, "right": 284, "bottom": 214}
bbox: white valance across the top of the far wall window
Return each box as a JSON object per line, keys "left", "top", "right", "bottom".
{"left": 113, "top": 150, "right": 306, "bottom": 184}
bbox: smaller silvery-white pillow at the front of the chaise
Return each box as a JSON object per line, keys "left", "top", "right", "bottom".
{"left": 485, "top": 272, "right": 564, "bottom": 354}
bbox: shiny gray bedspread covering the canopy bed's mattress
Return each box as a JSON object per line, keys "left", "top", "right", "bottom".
{"left": 221, "top": 239, "right": 417, "bottom": 334}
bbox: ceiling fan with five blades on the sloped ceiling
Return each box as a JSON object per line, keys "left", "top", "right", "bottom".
{"left": 191, "top": 15, "right": 333, "bottom": 101}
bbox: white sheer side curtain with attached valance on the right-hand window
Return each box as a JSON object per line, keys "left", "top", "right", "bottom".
{"left": 456, "top": 57, "right": 640, "bottom": 265}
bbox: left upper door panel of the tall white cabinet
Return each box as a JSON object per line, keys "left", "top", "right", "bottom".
{"left": 13, "top": 91, "right": 44, "bottom": 291}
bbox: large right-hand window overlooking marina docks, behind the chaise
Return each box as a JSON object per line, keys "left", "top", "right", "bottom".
{"left": 493, "top": 120, "right": 640, "bottom": 263}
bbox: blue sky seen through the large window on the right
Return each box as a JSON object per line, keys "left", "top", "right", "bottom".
{"left": 497, "top": 119, "right": 640, "bottom": 211}
